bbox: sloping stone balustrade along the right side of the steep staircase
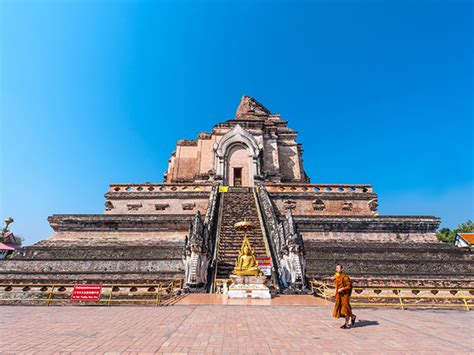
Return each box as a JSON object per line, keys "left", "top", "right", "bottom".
{"left": 254, "top": 185, "right": 282, "bottom": 289}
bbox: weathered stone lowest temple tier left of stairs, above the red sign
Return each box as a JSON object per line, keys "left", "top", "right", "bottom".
{"left": 0, "top": 239, "right": 184, "bottom": 284}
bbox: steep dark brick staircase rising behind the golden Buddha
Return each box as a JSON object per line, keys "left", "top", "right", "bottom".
{"left": 216, "top": 187, "right": 267, "bottom": 279}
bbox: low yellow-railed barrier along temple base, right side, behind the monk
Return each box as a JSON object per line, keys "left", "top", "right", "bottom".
{"left": 311, "top": 281, "right": 474, "bottom": 311}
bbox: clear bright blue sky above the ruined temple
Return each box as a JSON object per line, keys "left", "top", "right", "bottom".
{"left": 0, "top": 0, "right": 474, "bottom": 244}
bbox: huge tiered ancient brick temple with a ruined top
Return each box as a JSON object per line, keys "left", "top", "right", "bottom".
{"left": 0, "top": 96, "right": 474, "bottom": 292}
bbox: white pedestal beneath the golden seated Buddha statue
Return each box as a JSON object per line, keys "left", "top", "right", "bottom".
{"left": 227, "top": 275, "right": 272, "bottom": 299}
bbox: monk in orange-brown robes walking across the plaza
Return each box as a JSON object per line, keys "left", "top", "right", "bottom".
{"left": 331, "top": 264, "right": 357, "bottom": 329}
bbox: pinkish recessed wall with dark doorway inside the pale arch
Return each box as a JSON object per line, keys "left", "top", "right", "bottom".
{"left": 225, "top": 144, "right": 253, "bottom": 186}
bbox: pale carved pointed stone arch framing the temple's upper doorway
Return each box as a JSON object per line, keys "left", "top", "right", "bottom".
{"left": 214, "top": 125, "right": 262, "bottom": 186}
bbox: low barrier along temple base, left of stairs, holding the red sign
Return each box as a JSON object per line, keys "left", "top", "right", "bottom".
{"left": 0, "top": 280, "right": 183, "bottom": 306}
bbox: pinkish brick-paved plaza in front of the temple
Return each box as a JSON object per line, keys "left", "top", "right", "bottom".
{"left": 0, "top": 305, "right": 474, "bottom": 354}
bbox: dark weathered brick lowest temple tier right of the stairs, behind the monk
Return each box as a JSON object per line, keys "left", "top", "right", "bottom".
{"left": 305, "top": 239, "right": 474, "bottom": 287}
